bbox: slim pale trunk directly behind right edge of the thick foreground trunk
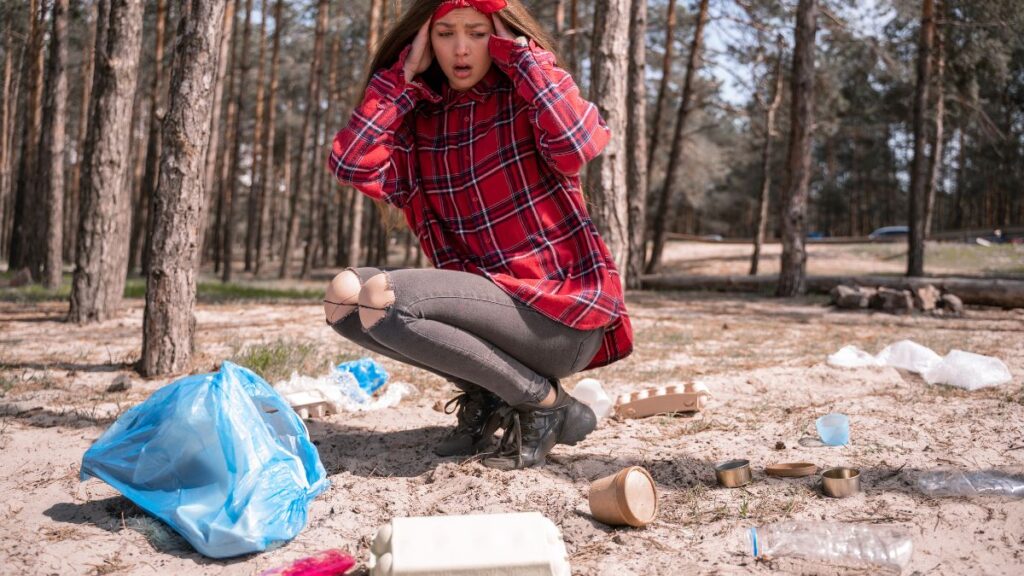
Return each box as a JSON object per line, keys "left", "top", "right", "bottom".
{"left": 198, "top": 0, "right": 238, "bottom": 265}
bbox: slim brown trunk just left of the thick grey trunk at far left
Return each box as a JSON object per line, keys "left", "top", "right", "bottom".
{"left": 7, "top": 0, "right": 46, "bottom": 280}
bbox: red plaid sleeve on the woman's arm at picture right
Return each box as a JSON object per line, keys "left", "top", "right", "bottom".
{"left": 488, "top": 35, "right": 610, "bottom": 176}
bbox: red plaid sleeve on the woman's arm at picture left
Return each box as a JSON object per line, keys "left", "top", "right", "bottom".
{"left": 328, "top": 46, "right": 440, "bottom": 208}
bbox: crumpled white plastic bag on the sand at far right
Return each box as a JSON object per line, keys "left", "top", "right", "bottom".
{"left": 827, "top": 340, "right": 1012, "bottom": 390}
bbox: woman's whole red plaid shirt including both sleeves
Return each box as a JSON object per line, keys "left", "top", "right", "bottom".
{"left": 330, "top": 36, "right": 633, "bottom": 369}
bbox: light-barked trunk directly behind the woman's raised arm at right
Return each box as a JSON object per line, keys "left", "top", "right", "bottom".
{"left": 587, "top": 0, "right": 632, "bottom": 286}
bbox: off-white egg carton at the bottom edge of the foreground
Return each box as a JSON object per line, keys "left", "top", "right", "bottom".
{"left": 368, "top": 512, "right": 571, "bottom": 576}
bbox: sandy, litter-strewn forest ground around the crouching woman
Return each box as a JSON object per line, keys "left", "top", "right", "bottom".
{"left": 0, "top": 243, "right": 1024, "bottom": 575}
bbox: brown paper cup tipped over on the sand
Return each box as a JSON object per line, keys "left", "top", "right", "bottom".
{"left": 589, "top": 466, "right": 657, "bottom": 528}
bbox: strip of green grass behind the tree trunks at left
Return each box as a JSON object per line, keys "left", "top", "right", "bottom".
{"left": 0, "top": 273, "right": 323, "bottom": 303}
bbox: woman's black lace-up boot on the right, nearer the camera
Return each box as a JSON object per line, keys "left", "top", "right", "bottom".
{"left": 482, "top": 382, "right": 597, "bottom": 470}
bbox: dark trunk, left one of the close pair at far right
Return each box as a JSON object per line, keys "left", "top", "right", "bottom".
{"left": 906, "top": 0, "right": 935, "bottom": 276}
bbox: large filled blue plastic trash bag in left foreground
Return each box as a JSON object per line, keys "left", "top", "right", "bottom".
{"left": 82, "top": 362, "right": 329, "bottom": 558}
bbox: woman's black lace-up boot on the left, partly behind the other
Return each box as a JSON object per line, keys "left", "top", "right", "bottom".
{"left": 434, "top": 388, "right": 507, "bottom": 456}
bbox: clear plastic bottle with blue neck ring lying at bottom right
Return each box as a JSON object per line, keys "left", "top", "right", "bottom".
{"left": 750, "top": 522, "right": 913, "bottom": 571}
